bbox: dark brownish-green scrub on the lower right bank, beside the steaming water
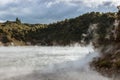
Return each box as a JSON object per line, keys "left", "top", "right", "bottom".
{"left": 92, "top": 50, "right": 120, "bottom": 76}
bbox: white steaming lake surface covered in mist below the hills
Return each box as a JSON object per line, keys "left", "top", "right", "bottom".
{"left": 0, "top": 46, "right": 111, "bottom": 80}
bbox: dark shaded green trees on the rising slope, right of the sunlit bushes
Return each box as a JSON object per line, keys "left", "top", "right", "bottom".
{"left": 27, "top": 12, "right": 116, "bottom": 45}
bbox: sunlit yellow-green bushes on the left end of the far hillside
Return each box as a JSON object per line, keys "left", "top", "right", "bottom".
{"left": 0, "top": 18, "right": 45, "bottom": 45}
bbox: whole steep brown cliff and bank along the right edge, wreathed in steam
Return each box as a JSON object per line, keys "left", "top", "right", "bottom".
{"left": 91, "top": 14, "right": 120, "bottom": 78}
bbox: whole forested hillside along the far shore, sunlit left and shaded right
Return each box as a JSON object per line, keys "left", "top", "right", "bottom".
{"left": 0, "top": 12, "right": 117, "bottom": 45}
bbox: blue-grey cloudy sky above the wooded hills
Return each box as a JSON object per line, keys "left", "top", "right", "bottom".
{"left": 0, "top": 0, "right": 120, "bottom": 24}
